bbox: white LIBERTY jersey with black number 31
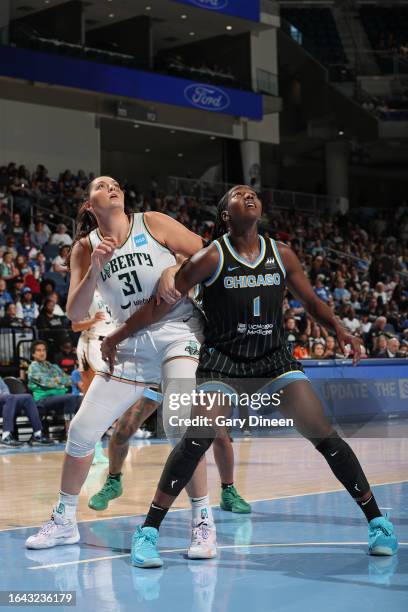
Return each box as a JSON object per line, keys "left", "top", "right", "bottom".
{"left": 88, "top": 213, "right": 194, "bottom": 326}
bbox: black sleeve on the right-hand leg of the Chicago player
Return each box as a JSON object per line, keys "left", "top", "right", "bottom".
{"left": 316, "top": 432, "right": 370, "bottom": 499}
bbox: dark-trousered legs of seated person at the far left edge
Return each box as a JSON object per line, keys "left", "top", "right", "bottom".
{"left": 0, "top": 376, "right": 53, "bottom": 448}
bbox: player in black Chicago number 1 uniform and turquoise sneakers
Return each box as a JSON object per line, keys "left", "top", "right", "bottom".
{"left": 104, "top": 185, "right": 397, "bottom": 567}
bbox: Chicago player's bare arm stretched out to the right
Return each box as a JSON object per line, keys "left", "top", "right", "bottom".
{"left": 278, "top": 243, "right": 361, "bottom": 365}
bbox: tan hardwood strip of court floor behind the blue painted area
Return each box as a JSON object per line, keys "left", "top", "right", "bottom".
{"left": 0, "top": 437, "right": 408, "bottom": 530}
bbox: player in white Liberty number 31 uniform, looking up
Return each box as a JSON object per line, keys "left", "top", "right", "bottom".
{"left": 26, "top": 177, "right": 244, "bottom": 558}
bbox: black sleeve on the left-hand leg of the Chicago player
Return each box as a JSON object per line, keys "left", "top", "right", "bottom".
{"left": 159, "top": 427, "right": 216, "bottom": 497}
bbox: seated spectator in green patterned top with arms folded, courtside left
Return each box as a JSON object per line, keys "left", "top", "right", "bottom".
{"left": 27, "top": 340, "right": 81, "bottom": 430}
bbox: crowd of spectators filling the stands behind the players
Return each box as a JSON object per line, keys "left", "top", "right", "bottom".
{"left": 0, "top": 163, "right": 408, "bottom": 373}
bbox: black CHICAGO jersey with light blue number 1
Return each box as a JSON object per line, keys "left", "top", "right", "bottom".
{"left": 203, "top": 234, "right": 285, "bottom": 362}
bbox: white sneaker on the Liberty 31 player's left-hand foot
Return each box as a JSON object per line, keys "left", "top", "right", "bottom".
{"left": 26, "top": 504, "right": 80, "bottom": 549}
